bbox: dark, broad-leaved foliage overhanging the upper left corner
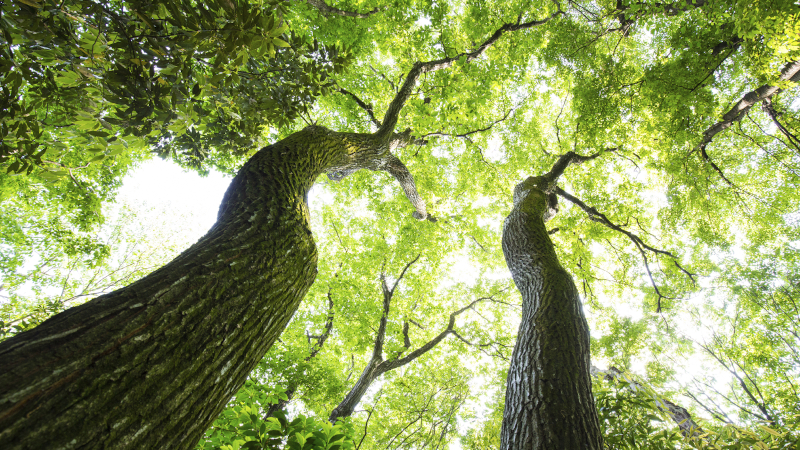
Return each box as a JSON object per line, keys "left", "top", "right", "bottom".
{"left": 0, "top": 0, "right": 343, "bottom": 178}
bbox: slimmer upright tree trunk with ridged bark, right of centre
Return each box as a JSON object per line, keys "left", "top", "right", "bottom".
{"left": 500, "top": 176, "right": 603, "bottom": 450}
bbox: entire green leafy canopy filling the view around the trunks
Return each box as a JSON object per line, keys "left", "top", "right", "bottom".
{"left": 0, "top": 0, "right": 800, "bottom": 450}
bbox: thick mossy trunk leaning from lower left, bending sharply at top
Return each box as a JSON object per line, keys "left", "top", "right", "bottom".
{"left": 0, "top": 127, "right": 425, "bottom": 450}
